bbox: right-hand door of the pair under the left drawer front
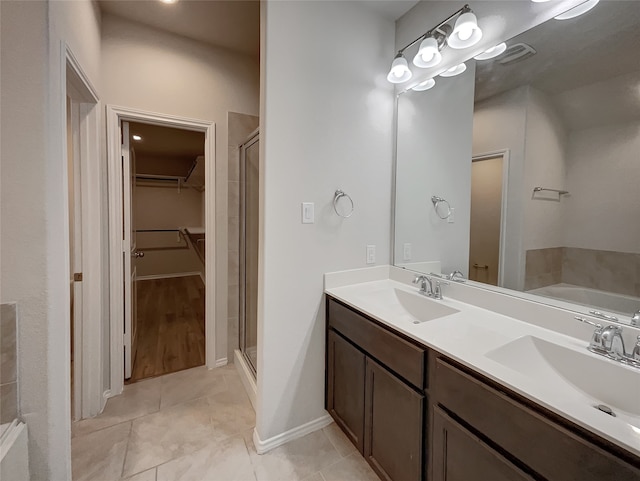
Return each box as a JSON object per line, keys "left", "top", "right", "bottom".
{"left": 364, "top": 358, "right": 425, "bottom": 481}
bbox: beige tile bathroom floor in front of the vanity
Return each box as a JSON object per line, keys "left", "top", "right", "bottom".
{"left": 71, "top": 365, "right": 379, "bottom": 481}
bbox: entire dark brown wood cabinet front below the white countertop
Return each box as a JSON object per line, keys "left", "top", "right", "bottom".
{"left": 326, "top": 297, "right": 640, "bottom": 481}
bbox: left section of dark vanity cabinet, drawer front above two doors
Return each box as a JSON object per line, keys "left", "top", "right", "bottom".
{"left": 326, "top": 300, "right": 426, "bottom": 481}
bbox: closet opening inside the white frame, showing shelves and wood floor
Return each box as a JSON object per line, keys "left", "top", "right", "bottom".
{"left": 122, "top": 121, "right": 206, "bottom": 382}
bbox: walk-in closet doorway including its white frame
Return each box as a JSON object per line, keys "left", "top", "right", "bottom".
{"left": 107, "top": 106, "right": 216, "bottom": 396}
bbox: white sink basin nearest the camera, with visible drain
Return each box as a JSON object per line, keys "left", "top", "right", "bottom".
{"left": 485, "top": 336, "right": 640, "bottom": 427}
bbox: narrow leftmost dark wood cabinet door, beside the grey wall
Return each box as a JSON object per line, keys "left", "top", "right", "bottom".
{"left": 327, "top": 330, "right": 365, "bottom": 453}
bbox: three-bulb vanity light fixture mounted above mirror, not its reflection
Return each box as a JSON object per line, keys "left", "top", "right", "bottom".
{"left": 387, "top": 5, "right": 482, "bottom": 84}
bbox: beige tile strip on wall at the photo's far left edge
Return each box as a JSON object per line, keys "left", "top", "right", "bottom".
{"left": 0, "top": 304, "right": 18, "bottom": 424}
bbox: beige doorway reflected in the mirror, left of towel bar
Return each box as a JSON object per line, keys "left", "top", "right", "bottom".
{"left": 469, "top": 151, "right": 508, "bottom": 286}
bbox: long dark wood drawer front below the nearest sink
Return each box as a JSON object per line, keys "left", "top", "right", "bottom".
{"left": 434, "top": 359, "right": 640, "bottom": 481}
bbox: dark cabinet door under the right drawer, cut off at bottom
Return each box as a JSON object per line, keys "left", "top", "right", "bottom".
{"left": 431, "top": 406, "right": 533, "bottom": 481}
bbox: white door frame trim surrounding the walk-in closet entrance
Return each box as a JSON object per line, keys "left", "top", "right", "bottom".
{"left": 106, "top": 105, "right": 218, "bottom": 396}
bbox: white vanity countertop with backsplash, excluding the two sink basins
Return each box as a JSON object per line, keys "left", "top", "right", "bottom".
{"left": 325, "top": 266, "right": 640, "bottom": 456}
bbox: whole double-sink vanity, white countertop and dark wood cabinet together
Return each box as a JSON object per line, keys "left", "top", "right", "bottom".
{"left": 325, "top": 268, "right": 640, "bottom": 481}
